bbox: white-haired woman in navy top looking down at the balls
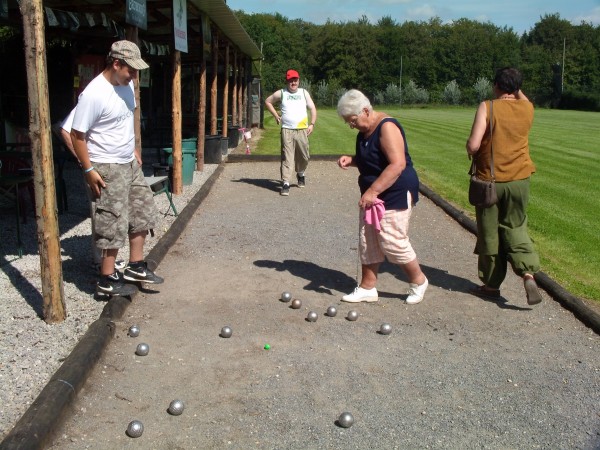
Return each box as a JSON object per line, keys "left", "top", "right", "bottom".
{"left": 337, "top": 89, "right": 429, "bottom": 304}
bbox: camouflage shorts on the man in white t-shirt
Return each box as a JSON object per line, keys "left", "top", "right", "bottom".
{"left": 93, "top": 160, "right": 158, "bottom": 249}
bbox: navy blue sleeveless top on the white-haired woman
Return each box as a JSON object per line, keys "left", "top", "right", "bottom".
{"left": 354, "top": 117, "right": 419, "bottom": 210}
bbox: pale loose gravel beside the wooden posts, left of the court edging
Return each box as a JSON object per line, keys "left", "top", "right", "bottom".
{"left": 0, "top": 159, "right": 217, "bottom": 440}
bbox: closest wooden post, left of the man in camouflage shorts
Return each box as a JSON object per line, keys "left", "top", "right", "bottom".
{"left": 19, "top": 0, "right": 67, "bottom": 323}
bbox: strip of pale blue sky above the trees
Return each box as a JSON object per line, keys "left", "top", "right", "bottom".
{"left": 227, "top": 0, "right": 600, "bottom": 34}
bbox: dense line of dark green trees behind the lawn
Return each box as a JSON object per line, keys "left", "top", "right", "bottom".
{"left": 236, "top": 11, "right": 600, "bottom": 111}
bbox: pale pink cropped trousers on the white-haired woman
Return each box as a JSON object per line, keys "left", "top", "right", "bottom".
{"left": 358, "top": 192, "right": 417, "bottom": 265}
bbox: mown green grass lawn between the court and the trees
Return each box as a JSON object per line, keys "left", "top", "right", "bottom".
{"left": 254, "top": 108, "right": 600, "bottom": 301}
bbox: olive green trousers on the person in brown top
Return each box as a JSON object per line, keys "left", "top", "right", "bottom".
{"left": 475, "top": 178, "right": 540, "bottom": 289}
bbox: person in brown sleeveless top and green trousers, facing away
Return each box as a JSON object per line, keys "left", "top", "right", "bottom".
{"left": 467, "top": 67, "right": 542, "bottom": 305}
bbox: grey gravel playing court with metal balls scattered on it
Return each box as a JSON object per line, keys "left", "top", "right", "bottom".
{"left": 35, "top": 161, "right": 600, "bottom": 450}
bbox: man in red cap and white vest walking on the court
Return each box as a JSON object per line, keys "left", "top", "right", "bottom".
{"left": 265, "top": 69, "right": 317, "bottom": 196}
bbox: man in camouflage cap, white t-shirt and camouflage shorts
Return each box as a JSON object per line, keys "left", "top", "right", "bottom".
{"left": 71, "top": 40, "right": 164, "bottom": 295}
